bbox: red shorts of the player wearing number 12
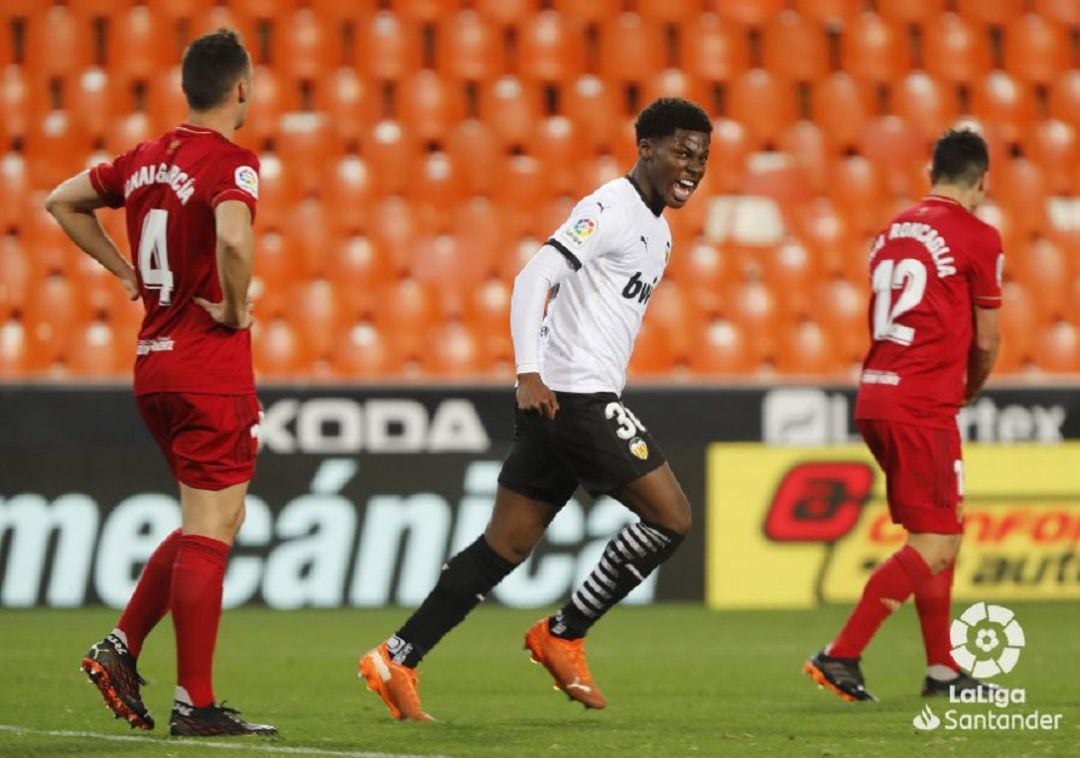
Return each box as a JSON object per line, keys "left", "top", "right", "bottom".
{"left": 855, "top": 419, "right": 963, "bottom": 534}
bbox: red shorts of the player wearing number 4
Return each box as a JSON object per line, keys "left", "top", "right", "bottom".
{"left": 135, "top": 392, "right": 259, "bottom": 489}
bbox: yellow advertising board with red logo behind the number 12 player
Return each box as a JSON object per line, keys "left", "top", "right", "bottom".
{"left": 705, "top": 443, "right": 1080, "bottom": 608}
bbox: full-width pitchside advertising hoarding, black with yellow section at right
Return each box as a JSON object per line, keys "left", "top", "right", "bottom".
{"left": 0, "top": 387, "right": 1080, "bottom": 609}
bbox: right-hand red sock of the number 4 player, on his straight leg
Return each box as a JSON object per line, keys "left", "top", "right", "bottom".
{"left": 172, "top": 534, "right": 229, "bottom": 708}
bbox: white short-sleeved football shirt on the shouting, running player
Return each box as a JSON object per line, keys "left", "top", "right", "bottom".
{"left": 540, "top": 177, "right": 672, "bottom": 394}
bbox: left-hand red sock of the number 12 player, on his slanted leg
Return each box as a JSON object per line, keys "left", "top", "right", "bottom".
{"left": 828, "top": 545, "right": 930, "bottom": 658}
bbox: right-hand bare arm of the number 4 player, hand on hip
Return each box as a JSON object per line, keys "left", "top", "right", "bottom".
{"left": 195, "top": 200, "right": 255, "bottom": 329}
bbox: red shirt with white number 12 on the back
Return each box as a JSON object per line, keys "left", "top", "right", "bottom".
{"left": 855, "top": 195, "right": 1004, "bottom": 429}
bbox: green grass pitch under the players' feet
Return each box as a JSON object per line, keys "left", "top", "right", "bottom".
{"left": 0, "top": 603, "right": 1080, "bottom": 758}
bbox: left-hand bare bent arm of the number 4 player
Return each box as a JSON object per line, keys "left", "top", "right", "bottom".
{"left": 45, "top": 171, "right": 139, "bottom": 300}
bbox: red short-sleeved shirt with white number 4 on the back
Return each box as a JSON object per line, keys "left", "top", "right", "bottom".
{"left": 90, "top": 124, "right": 259, "bottom": 395}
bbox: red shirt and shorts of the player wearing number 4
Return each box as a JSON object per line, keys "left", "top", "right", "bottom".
{"left": 90, "top": 124, "right": 259, "bottom": 489}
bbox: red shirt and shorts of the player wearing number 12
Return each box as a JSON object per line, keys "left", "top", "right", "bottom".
{"left": 855, "top": 195, "right": 1004, "bottom": 533}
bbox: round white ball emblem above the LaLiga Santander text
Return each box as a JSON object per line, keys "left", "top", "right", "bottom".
{"left": 949, "top": 603, "right": 1027, "bottom": 679}
